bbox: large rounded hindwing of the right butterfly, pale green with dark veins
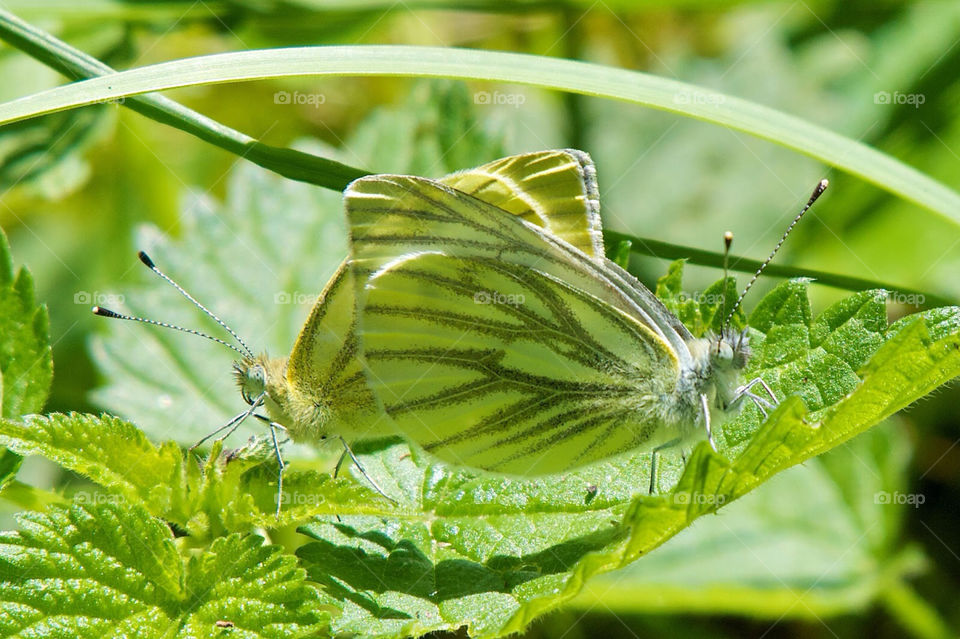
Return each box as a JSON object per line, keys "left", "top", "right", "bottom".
{"left": 362, "top": 253, "right": 677, "bottom": 475}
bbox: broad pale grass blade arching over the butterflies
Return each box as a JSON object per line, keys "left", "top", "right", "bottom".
{"left": 0, "top": 46, "right": 960, "bottom": 223}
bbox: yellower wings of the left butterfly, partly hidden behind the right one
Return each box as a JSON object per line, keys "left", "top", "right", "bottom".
{"left": 274, "top": 150, "right": 603, "bottom": 439}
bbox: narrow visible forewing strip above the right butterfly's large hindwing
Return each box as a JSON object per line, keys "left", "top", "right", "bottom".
{"left": 345, "top": 175, "right": 690, "bottom": 365}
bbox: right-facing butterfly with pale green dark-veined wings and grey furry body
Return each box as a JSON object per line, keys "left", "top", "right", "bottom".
{"left": 344, "top": 154, "right": 812, "bottom": 492}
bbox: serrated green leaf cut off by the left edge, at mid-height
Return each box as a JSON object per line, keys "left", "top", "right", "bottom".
{"left": 0, "top": 230, "right": 53, "bottom": 417}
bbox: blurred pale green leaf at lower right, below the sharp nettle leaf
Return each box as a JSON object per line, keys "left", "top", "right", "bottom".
{"left": 571, "top": 423, "right": 924, "bottom": 620}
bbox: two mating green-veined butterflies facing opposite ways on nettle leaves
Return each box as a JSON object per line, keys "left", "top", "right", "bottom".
{"left": 103, "top": 150, "right": 804, "bottom": 512}
